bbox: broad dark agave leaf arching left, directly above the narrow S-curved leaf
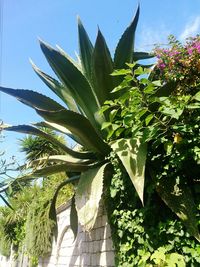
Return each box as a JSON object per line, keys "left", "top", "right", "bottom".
{"left": 37, "top": 110, "right": 110, "bottom": 155}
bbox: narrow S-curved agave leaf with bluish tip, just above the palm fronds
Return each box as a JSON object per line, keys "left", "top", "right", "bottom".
{"left": 4, "top": 125, "right": 94, "bottom": 159}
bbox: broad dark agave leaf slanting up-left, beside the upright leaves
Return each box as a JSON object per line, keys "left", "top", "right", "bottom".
{"left": 40, "top": 42, "right": 100, "bottom": 123}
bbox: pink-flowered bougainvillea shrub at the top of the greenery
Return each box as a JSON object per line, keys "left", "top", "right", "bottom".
{"left": 154, "top": 36, "right": 200, "bottom": 95}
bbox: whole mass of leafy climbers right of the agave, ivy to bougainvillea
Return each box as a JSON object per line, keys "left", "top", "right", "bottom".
{"left": 102, "top": 37, "right": 200, "bottom": 266}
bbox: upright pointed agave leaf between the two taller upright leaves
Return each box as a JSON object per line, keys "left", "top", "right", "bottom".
{"left": 92, "top": 30, "right": 114, "bottom": 105}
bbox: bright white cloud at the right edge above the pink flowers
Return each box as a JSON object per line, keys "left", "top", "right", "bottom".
{"left": 179, "top": 16, "right": 200, "bottom": 41}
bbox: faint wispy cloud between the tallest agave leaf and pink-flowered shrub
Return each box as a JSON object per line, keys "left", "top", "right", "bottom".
{"left": 136, "top": 25, "right": 170, "bottom": 51}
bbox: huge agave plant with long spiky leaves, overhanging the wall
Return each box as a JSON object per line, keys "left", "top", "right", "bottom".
{"left": 0, "top": 7, "right": 151, "bottom": 236}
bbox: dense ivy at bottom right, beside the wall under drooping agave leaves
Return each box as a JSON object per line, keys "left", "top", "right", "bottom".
{"left": 107, "top": 156, "right": 200, "bottom": 267}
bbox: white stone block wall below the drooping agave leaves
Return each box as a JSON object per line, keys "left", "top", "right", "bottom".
{"left": 38, "top": 204, "right": 115, "bottom": 267}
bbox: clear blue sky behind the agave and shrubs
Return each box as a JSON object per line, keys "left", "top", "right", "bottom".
{"left": 0, "top": 0, "right": 200, "bottom": 163}
